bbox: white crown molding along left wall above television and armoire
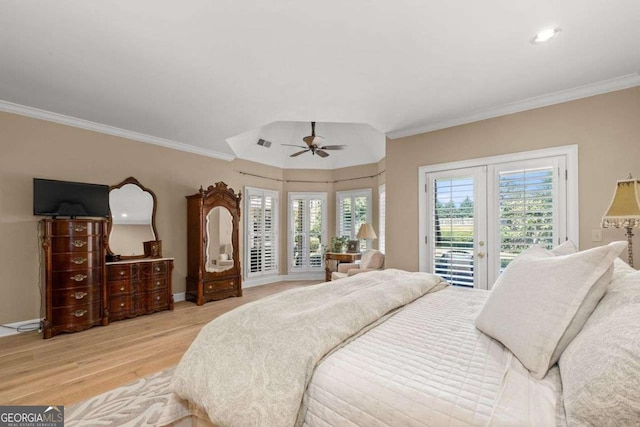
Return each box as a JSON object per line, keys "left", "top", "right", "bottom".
{"left": 0, "top": 100, "right": 236, "bottom": 161}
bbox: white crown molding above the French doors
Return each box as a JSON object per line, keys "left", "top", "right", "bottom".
{"left": 387, "top": 73, "right": 640, "bottom": 139}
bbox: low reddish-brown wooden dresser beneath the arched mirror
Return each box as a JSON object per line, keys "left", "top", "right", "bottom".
{"left": 106, "top": 258, "right": 173, "bottom": 320}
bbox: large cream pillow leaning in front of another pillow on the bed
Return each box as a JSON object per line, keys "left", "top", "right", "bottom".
{"left": 475, "top": 242, "right": 627, "bottom": 379}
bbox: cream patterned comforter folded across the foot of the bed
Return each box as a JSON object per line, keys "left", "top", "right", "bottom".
{"left": 171, "top": 270, "right": 447, "bottom": 427}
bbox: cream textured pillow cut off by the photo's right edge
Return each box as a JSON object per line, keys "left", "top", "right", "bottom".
{"left": 558, "top": 268, "right": 640, "bottom": 426}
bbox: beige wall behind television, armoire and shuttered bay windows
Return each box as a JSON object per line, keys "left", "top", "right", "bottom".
{"left": 0, "top": 113, "right": 379, "bottom": 323}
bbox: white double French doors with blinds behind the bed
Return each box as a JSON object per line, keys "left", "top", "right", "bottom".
{"left": 420, "top": 147, "right": 577, "bottom": 289}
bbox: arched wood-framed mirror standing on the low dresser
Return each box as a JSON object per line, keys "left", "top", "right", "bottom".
{"left": 107, "top": 177, "right": 159, "bottom": 259}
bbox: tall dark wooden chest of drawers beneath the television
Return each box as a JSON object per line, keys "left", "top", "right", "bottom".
{"left": 42, "top": 219, "right": 109, "bottom": 339}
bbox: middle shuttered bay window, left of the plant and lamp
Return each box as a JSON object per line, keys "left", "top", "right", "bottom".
{"left": 288, "top": 193, "right": 327, "bottom": 272}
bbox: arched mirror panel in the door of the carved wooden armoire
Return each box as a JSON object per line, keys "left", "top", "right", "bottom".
{"left": 205, "top": 206, "right": 234, "bottom": 273}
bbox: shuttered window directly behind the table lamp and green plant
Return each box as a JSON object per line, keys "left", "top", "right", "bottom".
{"left": 336, "top": 188, "right": 371, "bottom": 250}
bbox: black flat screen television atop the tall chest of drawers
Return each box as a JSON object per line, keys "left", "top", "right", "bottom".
{"left": 33, "top": 178, "right": 109, "bottom": 218}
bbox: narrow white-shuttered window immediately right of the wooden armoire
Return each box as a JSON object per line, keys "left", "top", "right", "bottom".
{"left": 244, "top": 187, "right": 278, "bottom": 278}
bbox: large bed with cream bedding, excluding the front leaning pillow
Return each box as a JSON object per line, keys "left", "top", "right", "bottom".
{"left": 163, "top": 244, "right": 640, "bottom": 427}
